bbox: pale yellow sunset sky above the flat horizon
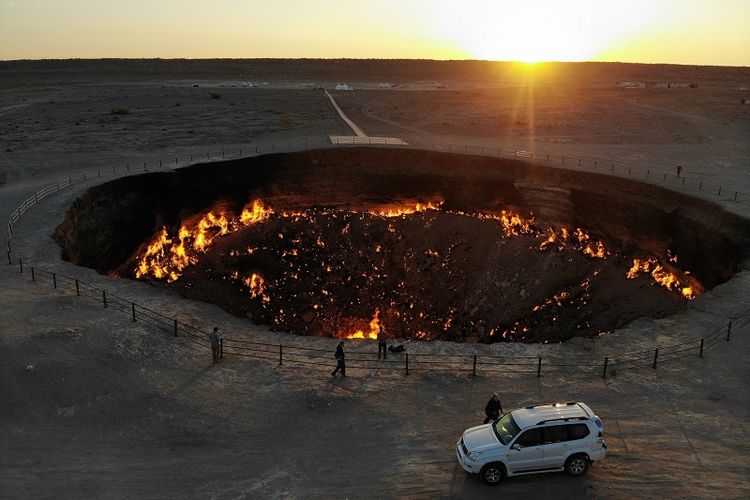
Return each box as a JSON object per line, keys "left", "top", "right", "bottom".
{"left": 0, "top": 0, "right": 750, "bottom": 66}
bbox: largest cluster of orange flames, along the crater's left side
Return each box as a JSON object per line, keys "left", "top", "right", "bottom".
{"left": 135, "top": 200, "right": 273, "bottom": 283}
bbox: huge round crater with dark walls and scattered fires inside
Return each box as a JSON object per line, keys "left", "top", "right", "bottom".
{"left": 55, "top": 148, "right": 750, "bottom": 342}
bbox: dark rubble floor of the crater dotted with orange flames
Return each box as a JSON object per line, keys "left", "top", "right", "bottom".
{"left": 125, "top": 200, "right": 695, "bottom": 342}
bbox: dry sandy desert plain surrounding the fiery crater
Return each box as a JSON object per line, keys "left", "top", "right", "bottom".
{"left": 0, "top": 61, "right": 750, "bottom": 498}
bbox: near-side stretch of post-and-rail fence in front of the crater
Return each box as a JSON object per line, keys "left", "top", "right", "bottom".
{"left": 11, "top": 259, "right": 750, "bottom": 378}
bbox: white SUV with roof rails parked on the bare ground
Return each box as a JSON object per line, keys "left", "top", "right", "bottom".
{"left": 456, "top": 402, "right": 607, "bottom": 485}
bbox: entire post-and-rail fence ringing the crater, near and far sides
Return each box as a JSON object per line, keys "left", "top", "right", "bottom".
{"left": 2, "top": 138, "right": 750, "bottom": 378}
